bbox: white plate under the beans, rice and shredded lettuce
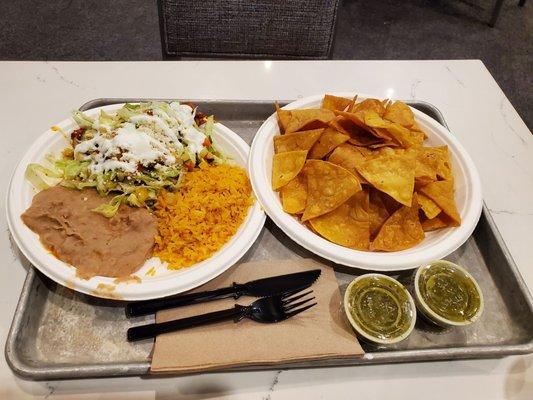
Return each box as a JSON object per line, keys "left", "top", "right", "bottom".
{"left": 7, "top": 104, "right": 265, "bottom": 300}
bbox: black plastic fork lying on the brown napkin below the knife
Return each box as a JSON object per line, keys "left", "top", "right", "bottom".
{"left": 128, "top": 288, "right": 317, "bottom": 342}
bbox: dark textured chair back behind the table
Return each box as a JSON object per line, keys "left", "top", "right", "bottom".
{"left": 159, "top": 0, "right": 339, "bottom": 59}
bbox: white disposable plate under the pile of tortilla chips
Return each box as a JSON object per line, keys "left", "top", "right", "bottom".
{"left": 249, "top": 93, "right": 483, "bottom": 271}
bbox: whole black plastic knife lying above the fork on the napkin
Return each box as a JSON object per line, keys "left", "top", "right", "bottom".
{"left": 126, "top": 269, "right": 321, "bottom": 317}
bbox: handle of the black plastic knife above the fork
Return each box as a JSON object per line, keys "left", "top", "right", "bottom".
{"left": 126, "top": 282, "right": 242, "bottom": 317}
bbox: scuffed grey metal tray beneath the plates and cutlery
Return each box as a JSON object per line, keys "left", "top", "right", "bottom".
{"left": 6, "top": 99, "right": 533, "bottom": 380}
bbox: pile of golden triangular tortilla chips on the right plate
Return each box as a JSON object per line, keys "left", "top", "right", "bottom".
{"left": 272, "top": 95, "right": 461, "bottom": 251}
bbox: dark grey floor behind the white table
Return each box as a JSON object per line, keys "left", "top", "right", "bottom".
{"left": 0, "top": 0, "right": 533, "bottom": 129}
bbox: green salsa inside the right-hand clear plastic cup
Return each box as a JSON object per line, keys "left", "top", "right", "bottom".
{"left": 418, "top": 262, "right": 481, "bottom": 322}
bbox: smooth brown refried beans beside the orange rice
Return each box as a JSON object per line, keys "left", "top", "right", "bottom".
{"left": 21, "top": 186, "right": 157, "bottom": 279}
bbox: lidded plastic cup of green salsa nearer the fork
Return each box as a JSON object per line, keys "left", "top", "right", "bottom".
{"left": 346, "top": 275, "right": 415, "bottom": 340}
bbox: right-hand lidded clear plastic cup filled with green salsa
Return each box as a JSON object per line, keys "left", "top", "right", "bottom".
{"left": 414, "top": 260, "right": 484, "bottom": 327}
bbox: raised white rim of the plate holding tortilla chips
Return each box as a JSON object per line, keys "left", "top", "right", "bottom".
{"left": 248, "top": 92, "right": 483, "bottom": 272}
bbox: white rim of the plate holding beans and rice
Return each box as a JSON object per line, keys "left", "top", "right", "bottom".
{"left": 5, "top": 103, "right": 266, "bottom": 301}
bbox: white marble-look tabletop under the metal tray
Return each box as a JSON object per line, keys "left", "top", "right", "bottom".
{"left": 0, "top": 60, "right": 533, "bottom": 400}
